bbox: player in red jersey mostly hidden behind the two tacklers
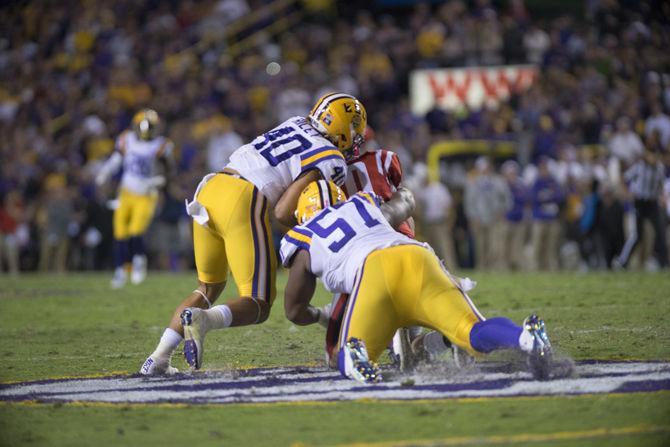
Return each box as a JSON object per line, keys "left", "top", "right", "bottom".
{"left": 326, "top": 127, "right": 414, "bottom": 368}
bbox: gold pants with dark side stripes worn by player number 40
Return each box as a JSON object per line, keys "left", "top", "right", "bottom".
{"left": 193, "top": 173, "right": 277, "bottom": 304}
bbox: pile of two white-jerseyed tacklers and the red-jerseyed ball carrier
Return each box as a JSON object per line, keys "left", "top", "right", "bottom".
{"left": 140, "top": 93, "right": 552, "bottom": 382}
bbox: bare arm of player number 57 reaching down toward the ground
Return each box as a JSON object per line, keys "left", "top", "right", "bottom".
{"left": 284, "top": 250, "right": 320, "bottom": 326}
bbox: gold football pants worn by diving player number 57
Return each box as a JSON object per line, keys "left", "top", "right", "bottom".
{"left": 340, "top": 245, "right": 484, "bottom": 361}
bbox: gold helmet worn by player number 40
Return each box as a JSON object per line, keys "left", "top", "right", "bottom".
{"left": 309, "top": 93, "right": 368, "bottom": 156}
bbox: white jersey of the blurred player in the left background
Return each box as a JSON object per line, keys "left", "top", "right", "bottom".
{"left": 116, "top": 131, "right": 174, "bottom": 195}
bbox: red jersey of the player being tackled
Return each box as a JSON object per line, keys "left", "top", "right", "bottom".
{"left": 342, "top": 149, "right": 414, "bottom": 238}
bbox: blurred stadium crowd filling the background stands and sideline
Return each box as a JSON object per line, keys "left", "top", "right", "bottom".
{"left": 0, "top": 0, "right": 670, "bottom": 272}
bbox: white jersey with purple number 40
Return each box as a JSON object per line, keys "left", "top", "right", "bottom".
{"left": 226, "top": 116, "right": 347, "bottom": 206}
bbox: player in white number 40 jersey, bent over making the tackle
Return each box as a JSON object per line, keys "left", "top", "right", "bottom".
{"left": 140, "top": 93, "right": 367, "bottom": 375}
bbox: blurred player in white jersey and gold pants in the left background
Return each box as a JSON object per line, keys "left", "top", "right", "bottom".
{"left": 95, "top": 109, "right": 174, "bottom": 289}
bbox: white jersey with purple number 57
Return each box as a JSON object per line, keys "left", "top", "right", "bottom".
{"left": 279, "top": 192, "right": 424, "bottom": 293}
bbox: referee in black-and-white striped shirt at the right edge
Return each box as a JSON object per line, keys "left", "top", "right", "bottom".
{"left": 613, "top": 148, "right": 668, "bottom": 268}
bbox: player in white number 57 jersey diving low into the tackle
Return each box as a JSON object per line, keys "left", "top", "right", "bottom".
{"left": 280, "top": 181, "right": 552, "bottom": 382}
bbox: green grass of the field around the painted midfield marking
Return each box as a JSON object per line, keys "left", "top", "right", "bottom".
{"left": 0, "top": 272, "right": 670, "bottom": 446}
